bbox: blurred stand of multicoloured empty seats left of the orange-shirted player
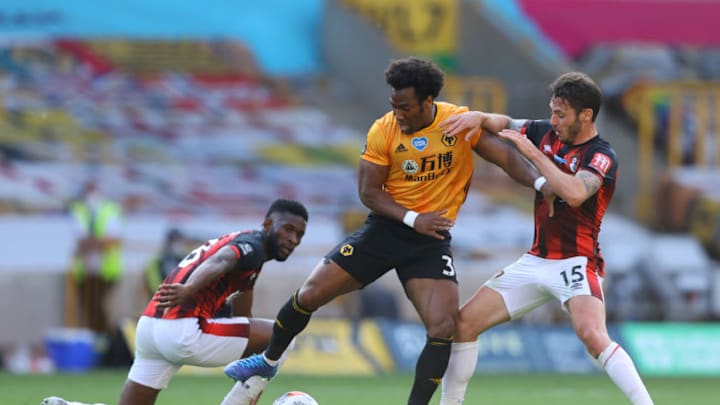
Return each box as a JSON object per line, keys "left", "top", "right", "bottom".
{"left": 0, "top": 39, "right": 362, "bottom": 215}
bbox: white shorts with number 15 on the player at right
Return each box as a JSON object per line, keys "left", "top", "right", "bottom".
{"left": 485, "top": 253, "right": 604, "bottom": 319}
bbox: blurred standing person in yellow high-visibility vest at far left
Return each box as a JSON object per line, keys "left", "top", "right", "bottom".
{"left": 70, "top": 181, "right": 123, "bottom": 334}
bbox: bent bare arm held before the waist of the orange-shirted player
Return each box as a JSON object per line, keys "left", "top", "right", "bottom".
{"left": 358, "top": 159, "right": 407, "bottom": 222}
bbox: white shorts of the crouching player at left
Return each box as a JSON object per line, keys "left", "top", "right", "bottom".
{"left": 128, "top": 316, "right": 250, "bottom": 390}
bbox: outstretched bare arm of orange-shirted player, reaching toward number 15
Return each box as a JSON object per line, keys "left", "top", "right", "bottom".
{"left": 475, "top": 131, "right": 540, "bottom": 187}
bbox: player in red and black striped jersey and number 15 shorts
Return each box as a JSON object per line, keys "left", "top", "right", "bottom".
{"left": 440, "top": 72, "right": 653, "bottom": 405}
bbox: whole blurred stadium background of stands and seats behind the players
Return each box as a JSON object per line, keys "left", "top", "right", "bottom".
{"left": 0, "top": 0, "right": 720, "bottom": 360}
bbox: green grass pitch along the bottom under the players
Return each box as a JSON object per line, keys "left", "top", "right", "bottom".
{"left": 0, "top": 369, "right": 718, "bottom": 405}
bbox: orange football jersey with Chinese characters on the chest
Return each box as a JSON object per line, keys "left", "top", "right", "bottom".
{"left": 362, "top": 102, "right": 479, "bottom": 220}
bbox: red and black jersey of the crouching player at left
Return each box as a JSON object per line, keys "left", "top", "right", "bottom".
{"left": 143, "top": 230, "right": 266, "bottom": 319}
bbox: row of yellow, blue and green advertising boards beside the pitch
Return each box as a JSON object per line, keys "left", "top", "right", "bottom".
{"left": 121, "top": 319, "right": 720, "bottom": 376}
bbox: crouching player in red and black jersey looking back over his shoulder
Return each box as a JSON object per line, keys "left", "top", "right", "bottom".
{"left": 119, "top": 199, "right": 308, "bottom": 405}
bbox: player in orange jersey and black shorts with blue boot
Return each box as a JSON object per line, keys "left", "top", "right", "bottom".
{"left": 225, "top": 57, "right": 539, "bottom": 405}
